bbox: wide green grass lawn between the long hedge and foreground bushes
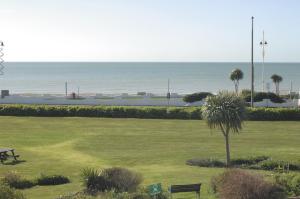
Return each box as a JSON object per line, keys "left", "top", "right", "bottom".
{"left": 0, "top": 117, "right": 300, "bottom": 199}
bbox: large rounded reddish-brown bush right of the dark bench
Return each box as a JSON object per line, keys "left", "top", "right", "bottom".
{"left": 214, "top": 169, "right": 286, "bottom": 199}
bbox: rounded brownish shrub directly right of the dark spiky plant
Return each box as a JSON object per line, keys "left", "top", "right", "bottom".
{"left": 101, "top": 167, "right": 143, "bottom": 192}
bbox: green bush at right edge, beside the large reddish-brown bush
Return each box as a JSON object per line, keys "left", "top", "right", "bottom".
{"left": 275, "top": 174, "right": 300, "bottom": 196}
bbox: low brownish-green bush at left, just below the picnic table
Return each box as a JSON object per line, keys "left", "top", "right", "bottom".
{"left": 3, "top": 172, "right": 35, "bottom": 189}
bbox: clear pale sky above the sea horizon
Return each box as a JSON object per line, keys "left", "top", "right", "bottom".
{"left": 0, "top": 0, "right": 300, "bottom": 62}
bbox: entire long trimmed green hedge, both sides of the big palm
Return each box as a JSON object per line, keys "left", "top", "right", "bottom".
{"left": 0, "top": 105, "right": 300, "bottom": 121}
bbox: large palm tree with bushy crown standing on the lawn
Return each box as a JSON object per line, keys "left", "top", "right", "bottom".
{"left": 202, "top": 91, "right": 246, "bottom": 166}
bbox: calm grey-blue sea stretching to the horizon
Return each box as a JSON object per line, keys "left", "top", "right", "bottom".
{"left": 0, "top": 63, "right": 300, "bottom": 94}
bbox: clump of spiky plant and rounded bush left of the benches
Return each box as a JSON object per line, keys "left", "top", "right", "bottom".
{"left": 82, "top": 167, "right": 143, "bottom": 193}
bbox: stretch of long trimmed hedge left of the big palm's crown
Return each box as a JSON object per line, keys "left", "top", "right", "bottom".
{"left": 0, "top": 105, "right": 201, "bottom": 119}
